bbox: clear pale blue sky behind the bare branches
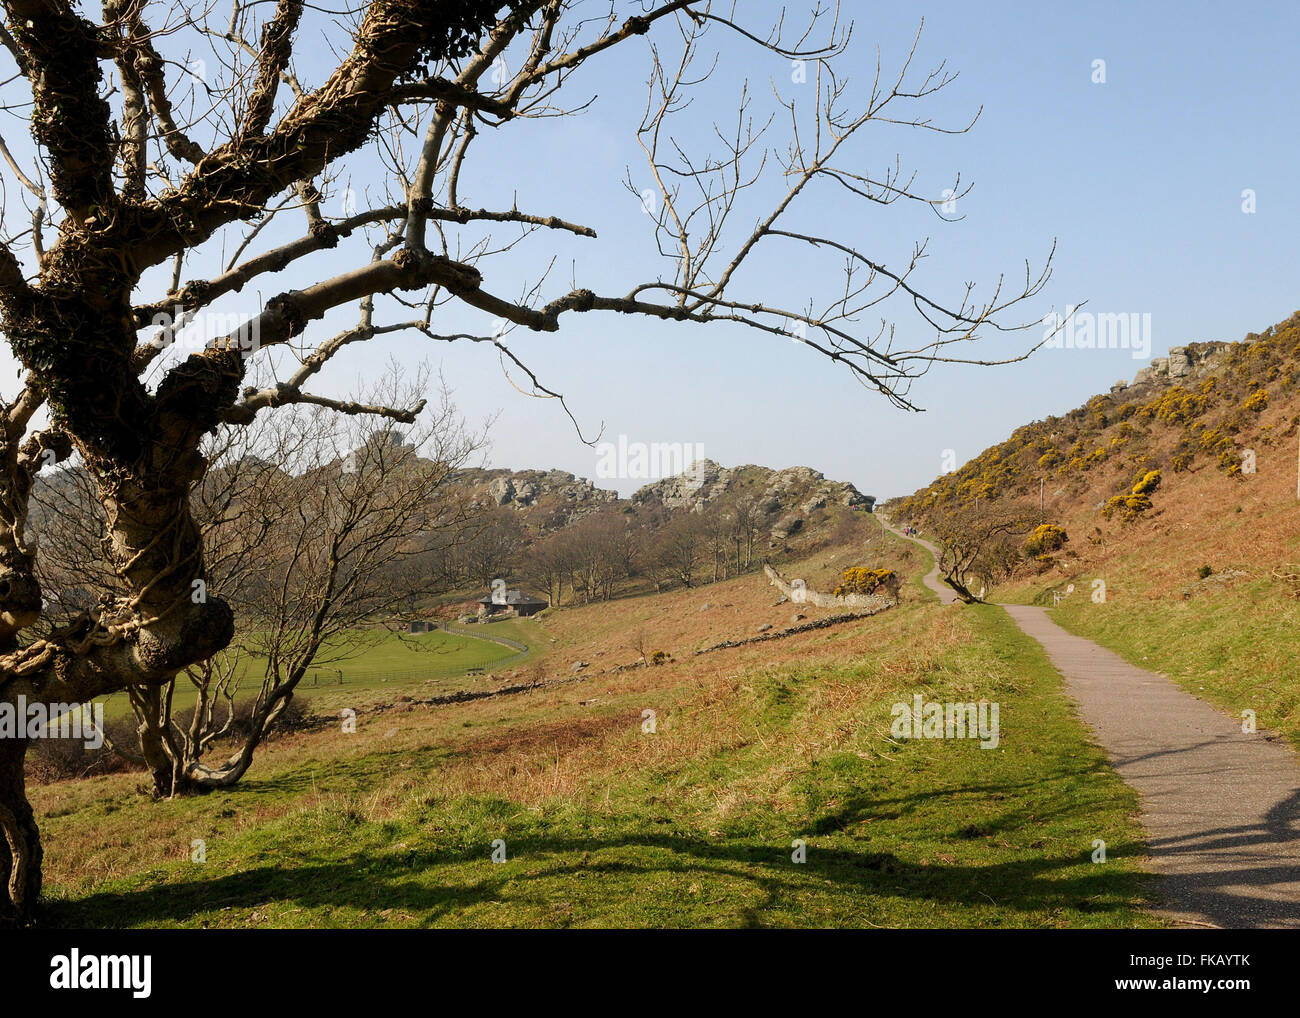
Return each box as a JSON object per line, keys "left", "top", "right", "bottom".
{"left": 5, "top": 0, "right": 1300, "bottom": 497}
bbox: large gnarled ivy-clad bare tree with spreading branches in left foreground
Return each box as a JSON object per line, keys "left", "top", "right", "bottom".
{"left": 0, "top": 0, "right": 1050, "bottom": 922}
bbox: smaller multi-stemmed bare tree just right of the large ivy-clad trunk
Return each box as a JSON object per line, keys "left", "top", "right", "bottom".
{"left": 38, "top": 374, "right": 482, "bottom": 796}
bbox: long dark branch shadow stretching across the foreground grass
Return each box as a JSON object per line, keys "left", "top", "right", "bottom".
{"left": 42, "top": 831, "right": 1148, "bottom": 928}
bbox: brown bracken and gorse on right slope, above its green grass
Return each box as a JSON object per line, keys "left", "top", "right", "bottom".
{"left": 893, "top": 313, "right": 1300, "bottom": 590}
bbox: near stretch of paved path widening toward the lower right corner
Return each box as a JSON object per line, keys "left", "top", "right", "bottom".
{"left": 883, "top": 517, "right": 1300, "bottom": 928}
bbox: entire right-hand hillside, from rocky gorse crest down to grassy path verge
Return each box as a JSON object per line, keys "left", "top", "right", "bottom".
{"left": 892, "top": 306, "right": 1300, "bottom": 745}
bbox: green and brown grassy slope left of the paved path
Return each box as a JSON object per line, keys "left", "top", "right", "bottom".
{"left": 33, "top": 553, "right": 1157, "bottom": 927}
